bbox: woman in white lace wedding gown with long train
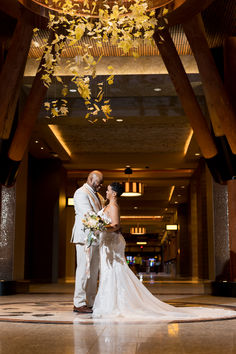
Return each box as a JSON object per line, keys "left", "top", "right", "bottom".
{"left": 92, "top": 182, "right": 236, "bottom": 322}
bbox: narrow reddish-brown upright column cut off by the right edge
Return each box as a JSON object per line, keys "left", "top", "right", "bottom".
{"left": 227, "top": 179, "right": 236, "bottom": 281}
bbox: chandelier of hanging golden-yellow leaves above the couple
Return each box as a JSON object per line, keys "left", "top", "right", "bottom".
{"left": 18, "top": 0, "right": 170, "bottom": 123}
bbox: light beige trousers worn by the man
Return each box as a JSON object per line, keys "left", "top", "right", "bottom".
{"left": 74, "top": 244, "right": 99, "bottom": 307}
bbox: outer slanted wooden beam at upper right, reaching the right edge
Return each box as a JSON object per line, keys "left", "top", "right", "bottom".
{"left": 183, "top": 14, "right": 236, "bottom": 154}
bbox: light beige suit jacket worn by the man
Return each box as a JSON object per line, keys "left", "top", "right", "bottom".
{"left": 71, "top": 183, "right": 104, "bottom": 243}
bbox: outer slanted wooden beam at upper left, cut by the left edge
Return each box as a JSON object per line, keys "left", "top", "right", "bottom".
{"left": 0, "top": 9, "right": 33, "bottom": 139}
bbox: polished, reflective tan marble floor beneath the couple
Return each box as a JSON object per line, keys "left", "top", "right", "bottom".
{"left": 0, "top": 284, "right": 236, "bottom": 354}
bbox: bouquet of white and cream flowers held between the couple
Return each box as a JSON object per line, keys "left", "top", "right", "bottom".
{"left": 82, "top": 211, "right": 110, "bottom": 247}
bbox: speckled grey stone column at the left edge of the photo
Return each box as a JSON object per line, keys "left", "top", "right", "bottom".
{"left": 0, "top": 186, "right": 16, "bottom": 295}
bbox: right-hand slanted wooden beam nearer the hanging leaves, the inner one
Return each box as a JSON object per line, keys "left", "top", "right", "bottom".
{"left": 154, "top": 28, "right": 217, "bottom": 159}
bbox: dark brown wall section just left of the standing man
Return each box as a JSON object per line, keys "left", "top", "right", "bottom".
{"left": 25, "top": 156, "right": 66, "bottom": 282}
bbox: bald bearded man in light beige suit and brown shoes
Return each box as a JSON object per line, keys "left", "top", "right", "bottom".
{"left": 71, "top": 171, "right": 104, "bottom": 313}
